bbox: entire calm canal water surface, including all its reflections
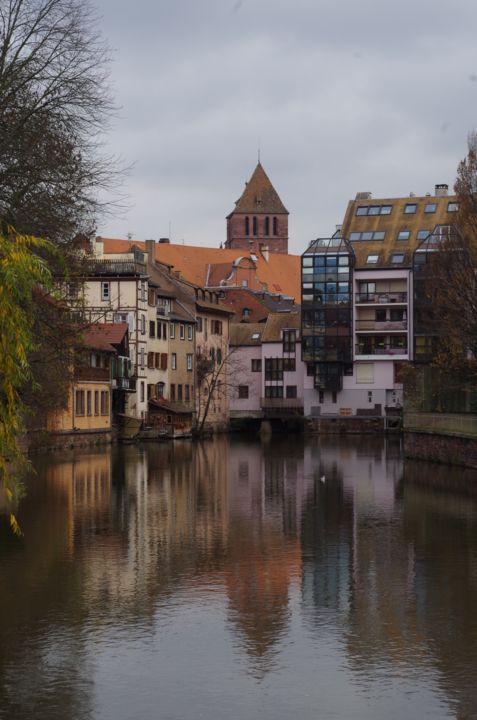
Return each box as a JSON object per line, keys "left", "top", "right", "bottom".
{"left": 0, "top": 437, "right": 477, "bottom": 720}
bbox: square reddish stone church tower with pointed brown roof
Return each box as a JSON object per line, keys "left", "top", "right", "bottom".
{"left": 225, "top": 162, "right": 288, "bottom": 254}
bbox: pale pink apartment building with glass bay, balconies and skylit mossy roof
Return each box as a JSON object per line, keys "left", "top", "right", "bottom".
{"left": 302, "top": 185, "right": 458, "bottom": 415}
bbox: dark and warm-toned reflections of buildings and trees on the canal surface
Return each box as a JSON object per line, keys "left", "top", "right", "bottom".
{"left": 0, "top": 437, "right": 477, "bottom": 718}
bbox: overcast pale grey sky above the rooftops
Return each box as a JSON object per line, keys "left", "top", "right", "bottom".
{"left": 93, "top": 0, "right": 477, "bottom": 254}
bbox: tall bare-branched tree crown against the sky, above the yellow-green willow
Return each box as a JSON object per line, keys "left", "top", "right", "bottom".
{"left": 0, "top": 0, "right": 118, "bottom": 243}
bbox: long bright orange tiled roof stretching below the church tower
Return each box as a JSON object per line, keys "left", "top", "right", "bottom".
{"left": 101, "top": 238, "right": 301, "bottom": 301}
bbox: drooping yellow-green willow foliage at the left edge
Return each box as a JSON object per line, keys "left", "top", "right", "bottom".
{"left": 0, "top": 228, "right": 54, "bottom": 530}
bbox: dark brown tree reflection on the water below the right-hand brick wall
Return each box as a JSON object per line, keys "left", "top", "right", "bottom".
{"left": 404, "top": 461, "right": 477, "bottom": 719}
